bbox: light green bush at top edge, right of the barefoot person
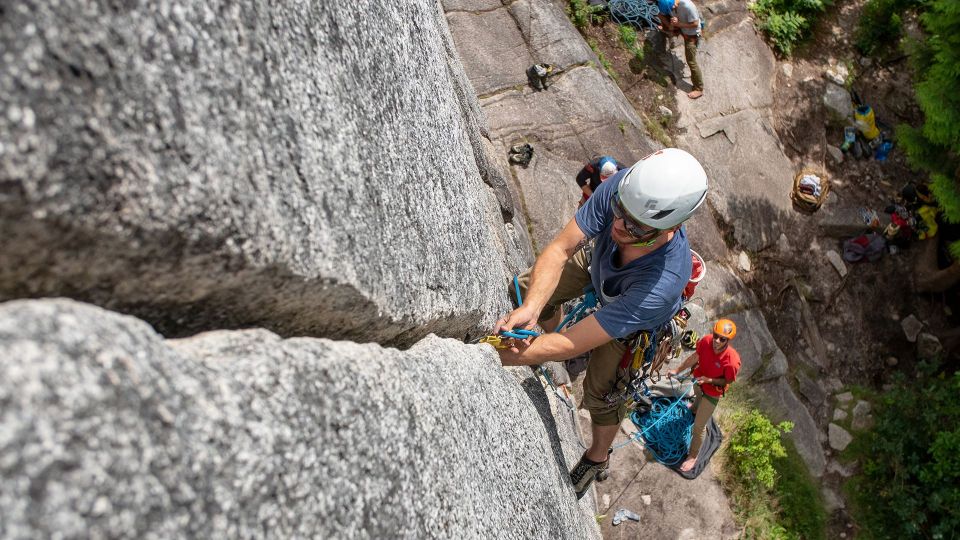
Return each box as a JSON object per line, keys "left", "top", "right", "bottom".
{"left": 749, "top": 0, "right": 832, "bottom": 56}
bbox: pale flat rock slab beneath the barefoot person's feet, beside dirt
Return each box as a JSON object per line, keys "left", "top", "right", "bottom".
{"left": 671, "top": 19, "right": 794, "bottom": 252}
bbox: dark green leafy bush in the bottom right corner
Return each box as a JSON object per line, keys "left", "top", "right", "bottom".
{"left": 849, "top": 364, "right": 960, "bottom": 538}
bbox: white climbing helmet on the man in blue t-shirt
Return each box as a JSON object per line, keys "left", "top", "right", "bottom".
{"left": 619, "top": 148, "right": 707, "bottom": 230}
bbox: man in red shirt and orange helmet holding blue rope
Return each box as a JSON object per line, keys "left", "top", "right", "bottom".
{"left": 667, "top": 319, "right": 740, "bottom": 472}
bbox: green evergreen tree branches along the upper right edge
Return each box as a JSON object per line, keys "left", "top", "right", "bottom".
{"left": 897, "top": 0, "right": 960, "bottom": 223}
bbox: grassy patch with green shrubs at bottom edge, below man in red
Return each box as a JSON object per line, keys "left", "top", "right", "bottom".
{"left": 714, "top": 387, "right": 827, "bottom": 540}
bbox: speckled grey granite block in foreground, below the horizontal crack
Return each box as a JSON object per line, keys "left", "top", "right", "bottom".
{"left": 0, "top": 300, "right": 599, "bottom": 538}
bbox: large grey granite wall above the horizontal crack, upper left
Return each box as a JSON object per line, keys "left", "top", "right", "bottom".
{"left": 0, "top": 0, "right": 529, "bottom": 343}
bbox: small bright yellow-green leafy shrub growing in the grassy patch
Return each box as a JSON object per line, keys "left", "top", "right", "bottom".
{"left": 730, "top": 409, "right": 793, "bottom": 491}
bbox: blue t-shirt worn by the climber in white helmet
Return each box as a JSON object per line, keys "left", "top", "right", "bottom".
{"left": 576, "top": 169, "right": 693, "bottom": 338}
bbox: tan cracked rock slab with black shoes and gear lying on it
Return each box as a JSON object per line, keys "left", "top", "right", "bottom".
{"left": 443, "top": 0, "right": 659, "bottom": 250}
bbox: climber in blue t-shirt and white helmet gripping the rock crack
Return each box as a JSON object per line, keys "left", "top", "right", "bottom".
{"left": 496, "top": 148, "right": 707, "bottom": 497}
